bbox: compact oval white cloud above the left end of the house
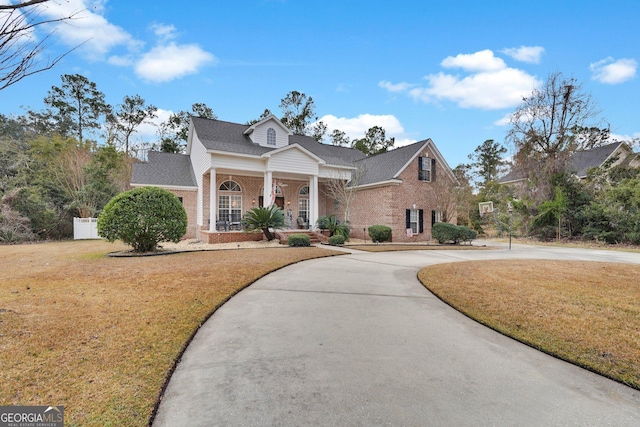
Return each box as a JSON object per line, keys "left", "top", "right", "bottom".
{"left": 135, "top": 42, "right": 217, "bottom": 83}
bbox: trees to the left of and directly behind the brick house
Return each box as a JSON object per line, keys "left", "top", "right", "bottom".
{"left": 0, "top": 74, "right": 394, "bottom": 242}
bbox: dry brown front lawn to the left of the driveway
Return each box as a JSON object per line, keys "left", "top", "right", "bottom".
{"left": 0, "top": 241, "right": 336, "bottom": 426}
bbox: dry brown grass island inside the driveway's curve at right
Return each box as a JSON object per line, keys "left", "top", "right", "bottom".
{"left": 418, "top": 260, "right": 640, "bottom": 389}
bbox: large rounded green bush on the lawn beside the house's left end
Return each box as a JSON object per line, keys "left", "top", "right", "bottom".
{"left": 98, "top": 187, "right": 187, "bottom": 252}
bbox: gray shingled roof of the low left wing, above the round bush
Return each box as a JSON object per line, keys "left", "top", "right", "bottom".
{"left": 131, "top": 151, "right": 197, "bottom": 187}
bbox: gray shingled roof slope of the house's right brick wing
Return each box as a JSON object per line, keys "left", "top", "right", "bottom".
{"left": 356, "top": 140, "right": 429, "bottom": 185}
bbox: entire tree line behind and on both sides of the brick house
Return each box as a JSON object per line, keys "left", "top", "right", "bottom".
{"left": 0, "top": 69, "right": 640, "bottom": 244}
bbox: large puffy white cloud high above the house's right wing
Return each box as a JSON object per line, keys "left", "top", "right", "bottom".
{"left": 378, "top": 50, "right": 542, "bottom": 110}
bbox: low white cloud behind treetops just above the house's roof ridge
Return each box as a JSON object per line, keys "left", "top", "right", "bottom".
{"left": 320, "top": 114, "right": 416, "bottom": 148}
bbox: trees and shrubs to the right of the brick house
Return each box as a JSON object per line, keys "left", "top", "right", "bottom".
{"left": 455, "top": 72, "right": 640, "bottom": 245}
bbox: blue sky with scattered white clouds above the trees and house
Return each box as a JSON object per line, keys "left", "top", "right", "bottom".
{"left": 0, "top": 0, "right": 640, "bottom": 167}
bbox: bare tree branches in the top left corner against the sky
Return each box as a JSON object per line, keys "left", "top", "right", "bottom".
{"left": 0, "top": 0, "right": 79, "bottom": 90}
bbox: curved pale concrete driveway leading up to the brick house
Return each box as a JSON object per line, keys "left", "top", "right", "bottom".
{"left": 154, "top": 245, "right": 640, "bottom": 427}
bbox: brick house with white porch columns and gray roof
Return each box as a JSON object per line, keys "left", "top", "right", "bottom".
{"left": 131, "top": 116, "right": 456, "bottom": 243}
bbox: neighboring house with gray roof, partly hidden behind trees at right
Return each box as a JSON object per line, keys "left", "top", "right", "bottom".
{"left": 498, "top": 142, "right": 640, "bottom": 184}
